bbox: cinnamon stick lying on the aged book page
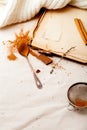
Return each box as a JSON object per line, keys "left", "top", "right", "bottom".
{"left": 74, "top": 18, "right": 87, "bottom": 44}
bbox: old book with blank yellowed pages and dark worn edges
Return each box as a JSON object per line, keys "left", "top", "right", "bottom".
{"left": 32, "top": 6, "right": 87, "bottom": 63}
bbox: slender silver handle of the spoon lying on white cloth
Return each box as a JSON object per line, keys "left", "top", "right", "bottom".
{"left": 26, "top": 57, "right": 42, "bottom": 89}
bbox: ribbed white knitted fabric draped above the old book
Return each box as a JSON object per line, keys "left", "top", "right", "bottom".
{"left": 0, "top": 0, "right": 87, "bottom": 27}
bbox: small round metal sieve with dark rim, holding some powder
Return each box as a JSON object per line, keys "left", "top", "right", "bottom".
{"left": 67, "top": 82, "right": 87, "bottom": 109}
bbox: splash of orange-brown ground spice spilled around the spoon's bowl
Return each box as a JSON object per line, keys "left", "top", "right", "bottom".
{"left": 7, "top": 29, "right": 31, "bottom": 60}
